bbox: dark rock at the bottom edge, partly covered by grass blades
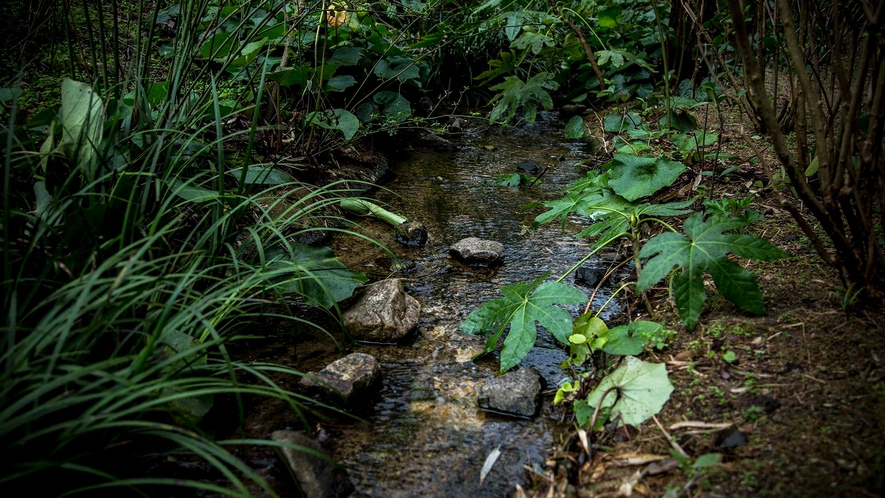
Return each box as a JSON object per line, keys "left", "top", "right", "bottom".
{"left": 270, "top": 431, "right": 353, "bottom": 498}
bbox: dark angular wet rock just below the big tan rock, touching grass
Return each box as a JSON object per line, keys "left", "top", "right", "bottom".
{"left": 301, "top": 353, "right": 381, "bottom": 404}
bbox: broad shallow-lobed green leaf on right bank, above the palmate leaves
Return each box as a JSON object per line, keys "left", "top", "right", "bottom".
{"left": 608, "top": 154, "right": 686, "bottom": 201}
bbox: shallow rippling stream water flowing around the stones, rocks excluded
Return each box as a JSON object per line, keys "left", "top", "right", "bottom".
{"left": 280, "top": 115, "right": 618, "bottom": 497}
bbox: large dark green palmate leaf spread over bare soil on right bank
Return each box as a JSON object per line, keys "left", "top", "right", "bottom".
{"left": 636, "top": 213, "right": 789, "bottom": 330}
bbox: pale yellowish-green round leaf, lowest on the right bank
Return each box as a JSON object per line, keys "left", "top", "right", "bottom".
{"left": 587, "top": 356, "right": 673, "bottom": 427}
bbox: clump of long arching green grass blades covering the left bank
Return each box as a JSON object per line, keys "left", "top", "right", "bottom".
{"left": 0, "top": 1, "right": 372, "bottom": 496}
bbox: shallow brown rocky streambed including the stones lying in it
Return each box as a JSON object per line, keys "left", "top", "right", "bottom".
{"left": 251, "top": 115, "right": 632, "bottom": 497}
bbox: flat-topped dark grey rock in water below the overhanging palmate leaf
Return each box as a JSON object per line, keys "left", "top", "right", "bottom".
{"left": 477, "top": 368, "right": 543, "bottom": 417}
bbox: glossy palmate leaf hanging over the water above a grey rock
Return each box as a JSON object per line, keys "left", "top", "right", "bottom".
{"left": 459, "top": 272, "right": 587, "bottom": 372}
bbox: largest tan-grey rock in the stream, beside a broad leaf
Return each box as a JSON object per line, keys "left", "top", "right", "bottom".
{"left": 342, "top": 278, "right": 421, "bottom": 343}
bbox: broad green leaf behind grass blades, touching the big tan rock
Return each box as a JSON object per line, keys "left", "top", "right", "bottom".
{"left": 266, "top": 244, "right": 367, "bottom": 308}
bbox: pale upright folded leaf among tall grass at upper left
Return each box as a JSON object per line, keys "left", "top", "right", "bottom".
{"left": 59, "top": 78, "right": 104, "bottom": 181}
